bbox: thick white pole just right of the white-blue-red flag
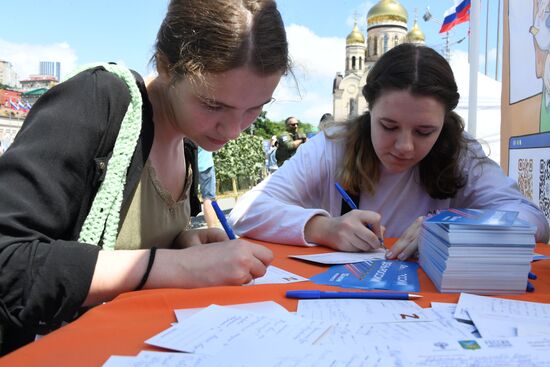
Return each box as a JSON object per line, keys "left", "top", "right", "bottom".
{"left": 468, "top": 0, "right": 480, "bottom": 138}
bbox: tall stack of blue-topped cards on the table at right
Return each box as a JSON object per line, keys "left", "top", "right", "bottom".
{"left": 419, "top": 209, "right": 536, "bottom": 294}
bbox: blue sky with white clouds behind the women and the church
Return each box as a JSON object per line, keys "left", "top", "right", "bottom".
{"left": 0, "top": 0, "right": 503, "bottom": 124}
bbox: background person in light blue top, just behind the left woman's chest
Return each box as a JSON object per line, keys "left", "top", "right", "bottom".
{"left": 198, "top": 147, "right": 217, "bottom": 228}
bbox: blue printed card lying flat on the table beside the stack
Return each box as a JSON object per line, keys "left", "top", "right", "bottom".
{"left": 309, "top": 260, "right": 420, "bottom": 292}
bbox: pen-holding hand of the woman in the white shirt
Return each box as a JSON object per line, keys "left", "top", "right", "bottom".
{"left": 304, "top": 210, "right": 383, "bottom": 252}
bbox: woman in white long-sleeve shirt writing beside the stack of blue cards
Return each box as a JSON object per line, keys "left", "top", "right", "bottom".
{"left": 230, "top": 43, "right": 549, "bottom": 260}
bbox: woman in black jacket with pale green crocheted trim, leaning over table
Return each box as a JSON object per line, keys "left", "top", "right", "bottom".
{"left": 0, "top": 0, "right": 290, "bottom": 353}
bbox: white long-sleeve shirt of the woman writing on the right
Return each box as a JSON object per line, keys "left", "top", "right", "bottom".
{"left": 229, "top": 129, "right": 549, "bottom": 245}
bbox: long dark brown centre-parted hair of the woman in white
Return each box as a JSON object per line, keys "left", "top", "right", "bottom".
{"left": 338, "top": 43, "right": 474, "bottom": 199}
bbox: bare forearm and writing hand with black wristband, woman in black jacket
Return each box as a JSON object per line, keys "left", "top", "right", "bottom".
{"left": 84, "top": 239, "right": 273, "bottom": 306}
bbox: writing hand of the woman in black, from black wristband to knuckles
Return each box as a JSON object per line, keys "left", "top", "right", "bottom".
{"left": 152, "top": 239, "right": 273, "bottom": 288}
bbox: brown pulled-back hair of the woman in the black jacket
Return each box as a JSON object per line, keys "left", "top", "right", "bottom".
{"left": 154, "top": 0, "right": 290, "bottom": 81}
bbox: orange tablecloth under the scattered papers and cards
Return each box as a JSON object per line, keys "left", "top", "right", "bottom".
{"left": 0, "top": 240, "right": 550, "bottom": 367}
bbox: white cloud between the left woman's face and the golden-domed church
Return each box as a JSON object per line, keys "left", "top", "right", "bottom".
{"left": 265, "top": 24, "right": 346, "bottom": 125}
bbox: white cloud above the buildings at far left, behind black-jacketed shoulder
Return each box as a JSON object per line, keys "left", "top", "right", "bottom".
{"left": 0, "top": 38, "right": 77, "bottom": 80}
